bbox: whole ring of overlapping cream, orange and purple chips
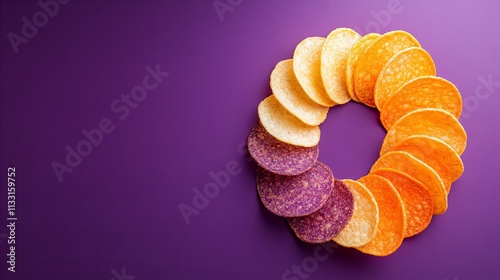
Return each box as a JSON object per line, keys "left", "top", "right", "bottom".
{"left": 247, "top": 28, "right": 467, "bottom": 256}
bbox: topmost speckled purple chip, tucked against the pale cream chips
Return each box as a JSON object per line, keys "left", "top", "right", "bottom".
{"left": 247, "top": 123, "right": 319, "bottom": 175}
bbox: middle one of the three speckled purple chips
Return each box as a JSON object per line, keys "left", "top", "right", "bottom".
{"left": 257, "top": 162, "right": 333, "bottom": 217}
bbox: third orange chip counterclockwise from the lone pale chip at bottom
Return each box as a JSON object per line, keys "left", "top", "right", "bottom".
{"left": 370, "top": 151, "right": 448, "bottom": 214}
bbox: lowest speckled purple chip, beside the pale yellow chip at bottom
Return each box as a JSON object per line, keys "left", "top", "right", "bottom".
{"left": 288, "top": 179, "right": 354, "bottom": 243}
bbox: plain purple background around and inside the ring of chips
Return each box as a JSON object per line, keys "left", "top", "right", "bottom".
{"left": 0, "top": 0, "right": 500, "bottom": 280}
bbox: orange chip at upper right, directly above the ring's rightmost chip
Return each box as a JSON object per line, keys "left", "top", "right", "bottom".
{"left": 380, "top": 76, "right": 462, "bottom": 130}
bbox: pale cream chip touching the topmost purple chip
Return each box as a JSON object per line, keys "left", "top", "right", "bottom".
{"left": 258, "top": 95, "right": 321, "bottom": 147}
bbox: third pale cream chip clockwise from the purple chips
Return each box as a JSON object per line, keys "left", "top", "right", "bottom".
{"left": 293, "top": 37, "right": 335, "bottom": 107}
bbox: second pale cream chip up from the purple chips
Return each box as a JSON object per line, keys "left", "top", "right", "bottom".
{"left": 271, "top": 59, "right": 328, "bottom": 126}
